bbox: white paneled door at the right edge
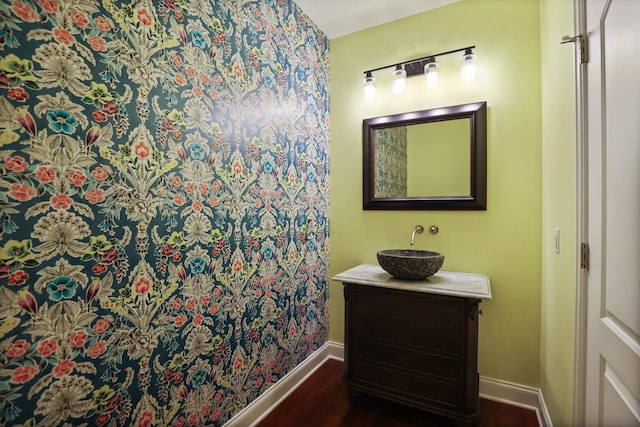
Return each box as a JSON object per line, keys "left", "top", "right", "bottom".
{"left": 583, "top": 0, "right": 640, "bottom": 427}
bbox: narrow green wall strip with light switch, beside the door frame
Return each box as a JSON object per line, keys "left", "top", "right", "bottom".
{"left": 540, "top": 0, "right": 577, "bottom": 426}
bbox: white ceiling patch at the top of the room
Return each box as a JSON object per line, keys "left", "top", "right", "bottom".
{"left": 294, "top": 0, "right": 460, "bottom": 39}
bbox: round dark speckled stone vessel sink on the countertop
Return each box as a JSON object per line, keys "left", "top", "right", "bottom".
{"left": 377, "top": 249, "right": 444, "bottom": 280}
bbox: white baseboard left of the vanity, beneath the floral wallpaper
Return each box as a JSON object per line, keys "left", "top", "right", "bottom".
{"left": 225, "top": 341, "right": 344, "bottom": 427}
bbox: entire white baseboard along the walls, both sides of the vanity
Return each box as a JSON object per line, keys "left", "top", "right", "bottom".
{"left": 225, "top": 341, "right": 553, "bottom": 427}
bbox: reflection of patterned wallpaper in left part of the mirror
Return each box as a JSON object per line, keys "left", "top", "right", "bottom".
{"left": 373, "top": 126, "right": 407, "bottom": 198}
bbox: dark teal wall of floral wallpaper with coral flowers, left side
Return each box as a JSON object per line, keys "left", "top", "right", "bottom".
{"left": 0, "top": 0, "right": 329, "bottom": 427}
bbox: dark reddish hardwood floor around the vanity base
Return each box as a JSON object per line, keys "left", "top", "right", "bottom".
{"left": 257, "top": 359, "right": 538, "bottom": 427}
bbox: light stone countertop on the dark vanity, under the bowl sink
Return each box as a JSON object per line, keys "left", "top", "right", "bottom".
{"left": 333, "top": 264, "right": 491, "bottom": 299}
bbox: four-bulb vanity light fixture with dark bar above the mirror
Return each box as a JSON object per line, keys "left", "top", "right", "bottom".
{"left": 362, "top": 46, "right": 477, "bottom": 99}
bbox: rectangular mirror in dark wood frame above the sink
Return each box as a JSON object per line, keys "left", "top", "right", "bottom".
{"left": 362, "top": 102, "right": 487, "bottom": 210}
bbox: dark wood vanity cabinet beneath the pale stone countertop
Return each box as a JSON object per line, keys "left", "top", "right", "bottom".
{"left": 344, "top": 282, "right": 480, "bottom": 425}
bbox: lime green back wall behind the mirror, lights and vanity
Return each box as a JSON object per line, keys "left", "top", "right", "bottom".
{"left": 329, "top": 0, "right": 542, "bottom": 387}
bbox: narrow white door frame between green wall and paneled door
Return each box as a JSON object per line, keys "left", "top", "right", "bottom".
{"left": 573, "top": 0, "right": 589, "bottom": 426}
